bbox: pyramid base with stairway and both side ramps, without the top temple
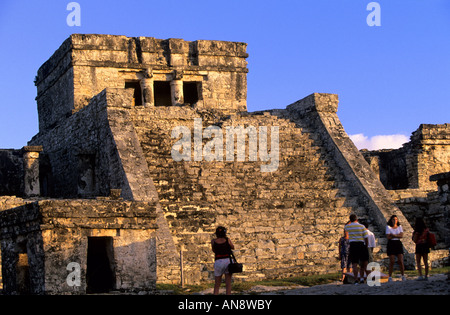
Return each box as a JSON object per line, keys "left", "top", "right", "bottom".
{"left": 30, "top": 88, "right": 418, "bottom": 283}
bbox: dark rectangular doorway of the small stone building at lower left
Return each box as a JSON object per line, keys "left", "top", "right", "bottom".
{"left": 86, "top": 237, "right": 115, "bottom": 293}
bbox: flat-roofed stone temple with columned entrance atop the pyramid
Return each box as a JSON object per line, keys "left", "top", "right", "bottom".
{"left": 36, "top": 34, "right": 248, "bottom": 131}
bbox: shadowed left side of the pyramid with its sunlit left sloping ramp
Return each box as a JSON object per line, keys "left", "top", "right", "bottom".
{"left": 29, "top": 88, "right": 180, "bottom": 281}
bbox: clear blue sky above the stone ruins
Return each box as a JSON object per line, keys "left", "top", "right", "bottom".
{"left": 0, "top": 0, "right": 450, "bottom": 148}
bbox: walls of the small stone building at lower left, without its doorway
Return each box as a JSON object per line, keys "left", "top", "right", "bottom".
{"left": 0, "top": 199, "right": 157, "bottom": 294}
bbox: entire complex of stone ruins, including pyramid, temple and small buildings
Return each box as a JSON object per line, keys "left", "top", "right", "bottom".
{"left": 0, "top": 34, "right": 450, "bottom": 294}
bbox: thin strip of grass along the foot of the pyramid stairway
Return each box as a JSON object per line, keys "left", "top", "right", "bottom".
{"left": 156, "top": 267, "right": 450, "bottom": 295}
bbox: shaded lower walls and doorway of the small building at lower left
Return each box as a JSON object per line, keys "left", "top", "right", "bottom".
{"left": 2, "top": 233, "right": 156, "bottom": 295}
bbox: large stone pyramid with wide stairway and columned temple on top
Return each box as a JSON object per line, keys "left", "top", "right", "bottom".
{"left": 0, "top": 35, "right": 446, "bottom": 283}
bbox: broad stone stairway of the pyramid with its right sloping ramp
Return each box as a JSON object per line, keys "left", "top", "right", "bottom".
{"left": 115, "top": 95, "right": 413, "bottom": 282}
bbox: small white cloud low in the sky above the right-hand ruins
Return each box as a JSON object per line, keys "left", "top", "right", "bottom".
{"left": 349, "top": 133, "right": 409, "bottom": 150}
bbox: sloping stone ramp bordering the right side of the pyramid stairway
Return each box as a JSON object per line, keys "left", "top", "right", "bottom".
{"left": 287, "top": 93, "right": 414, "bottom": 264}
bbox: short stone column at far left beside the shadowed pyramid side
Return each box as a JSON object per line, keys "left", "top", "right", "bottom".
{"left": 22, "top": 146, "right": 42, "bottom": 197}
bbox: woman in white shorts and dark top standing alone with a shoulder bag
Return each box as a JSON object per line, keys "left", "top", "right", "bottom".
{"left": 211, "top": 226, "right": 234, "bottom": 295}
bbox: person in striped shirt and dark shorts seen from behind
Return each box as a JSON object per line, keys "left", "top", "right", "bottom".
{"left": 344, "top": 214, "right": 369, "bottom": 284}
